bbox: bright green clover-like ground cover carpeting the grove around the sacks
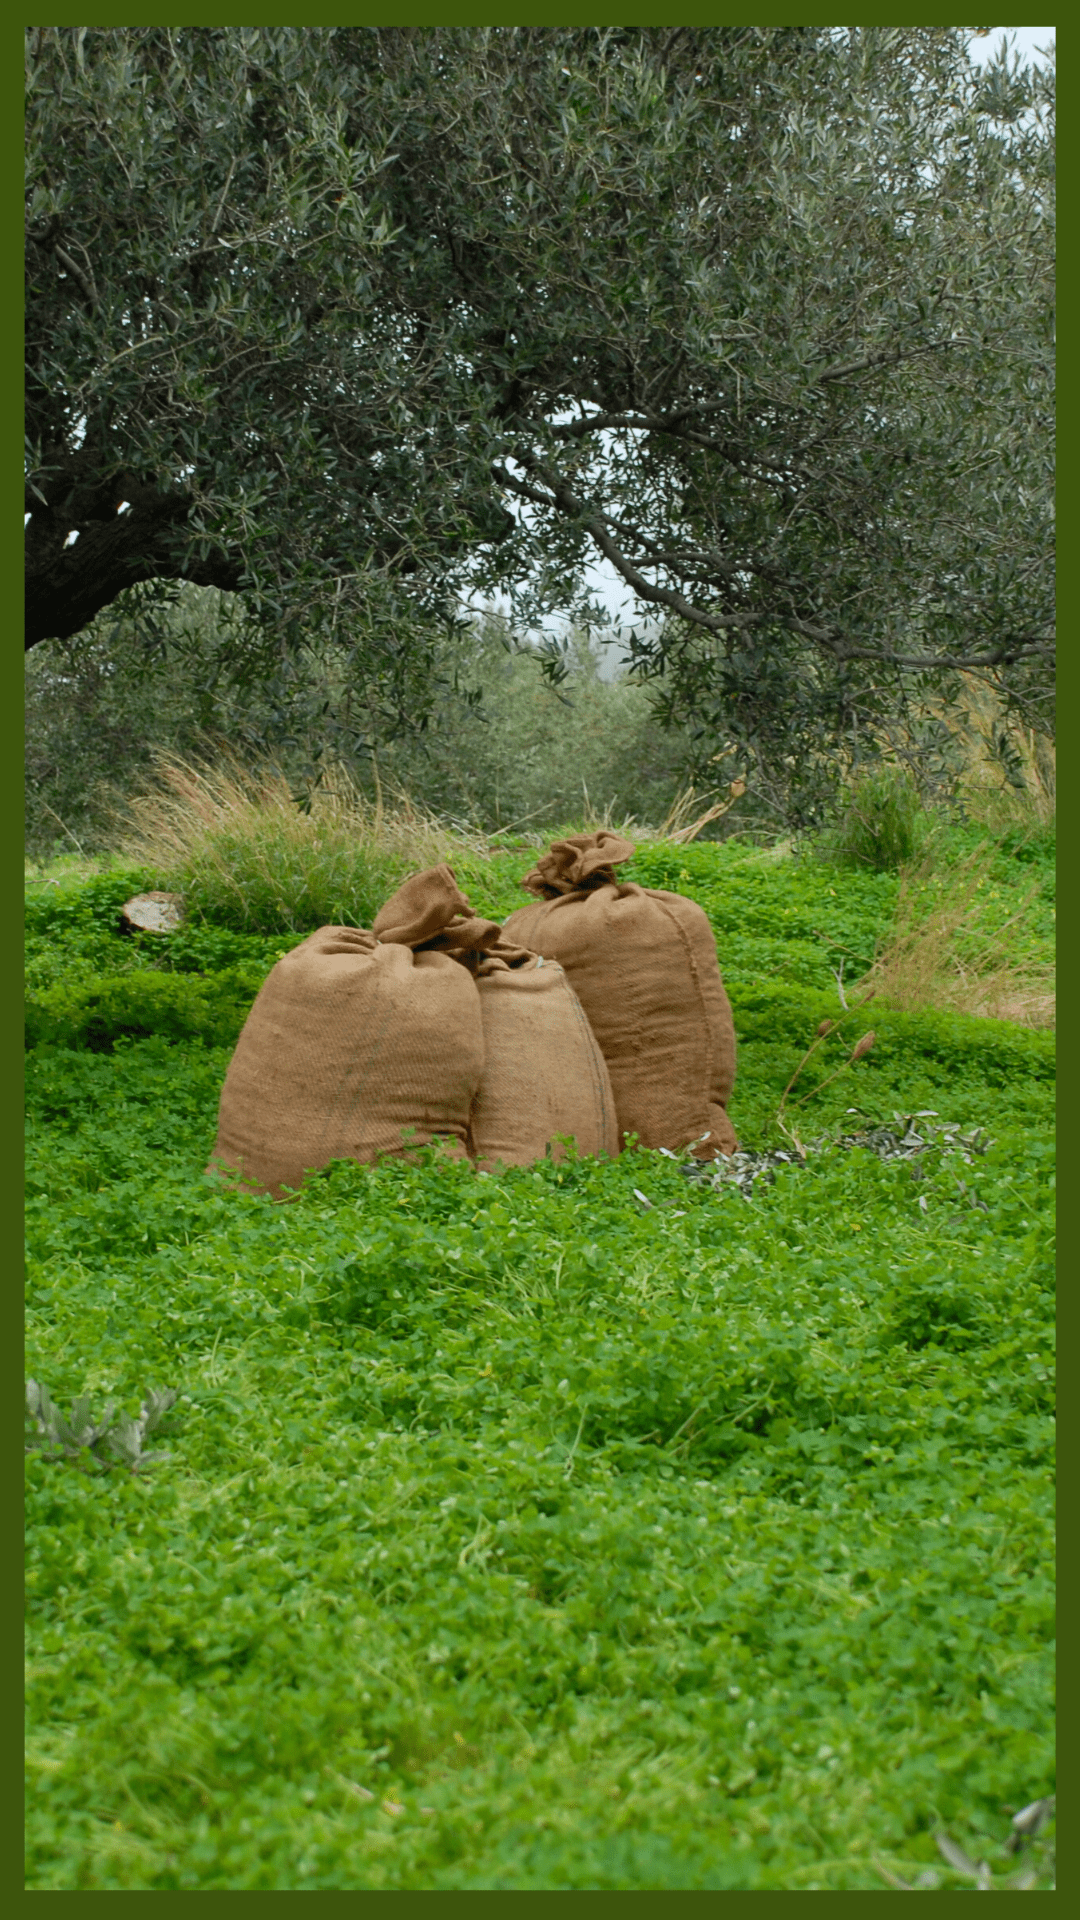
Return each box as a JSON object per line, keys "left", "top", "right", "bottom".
{"left": 27, "top": 847, "right": 1053, "bottom": 1889}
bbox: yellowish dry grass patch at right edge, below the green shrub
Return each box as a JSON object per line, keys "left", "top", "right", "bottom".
{"left": 861, "top": 841, "right": 1055, "bottom": 1027}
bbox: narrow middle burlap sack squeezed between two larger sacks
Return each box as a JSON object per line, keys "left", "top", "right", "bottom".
{"left": 469, "top": 947, "right": 619, "bottom": 1173}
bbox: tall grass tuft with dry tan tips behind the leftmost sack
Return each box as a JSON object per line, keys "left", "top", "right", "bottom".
{"left": 121, "top": 753, "right": 484, "bottom": 933}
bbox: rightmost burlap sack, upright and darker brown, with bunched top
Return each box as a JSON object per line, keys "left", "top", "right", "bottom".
{"left": 502, "top": 831, "right": 738, "bottom": 1160}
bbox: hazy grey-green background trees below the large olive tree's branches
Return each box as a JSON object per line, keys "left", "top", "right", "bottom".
{"left": 25, "top": 588, "right": 699, "bottom": 860}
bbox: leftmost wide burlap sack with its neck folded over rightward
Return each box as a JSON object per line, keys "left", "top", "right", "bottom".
{"left": 211, "top": 866, "right": 484, "bottom": 1198}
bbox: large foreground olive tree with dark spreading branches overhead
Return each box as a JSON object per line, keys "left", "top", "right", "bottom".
{"left": 27, "top": 27, "right": 1053, "bottom": 816}
